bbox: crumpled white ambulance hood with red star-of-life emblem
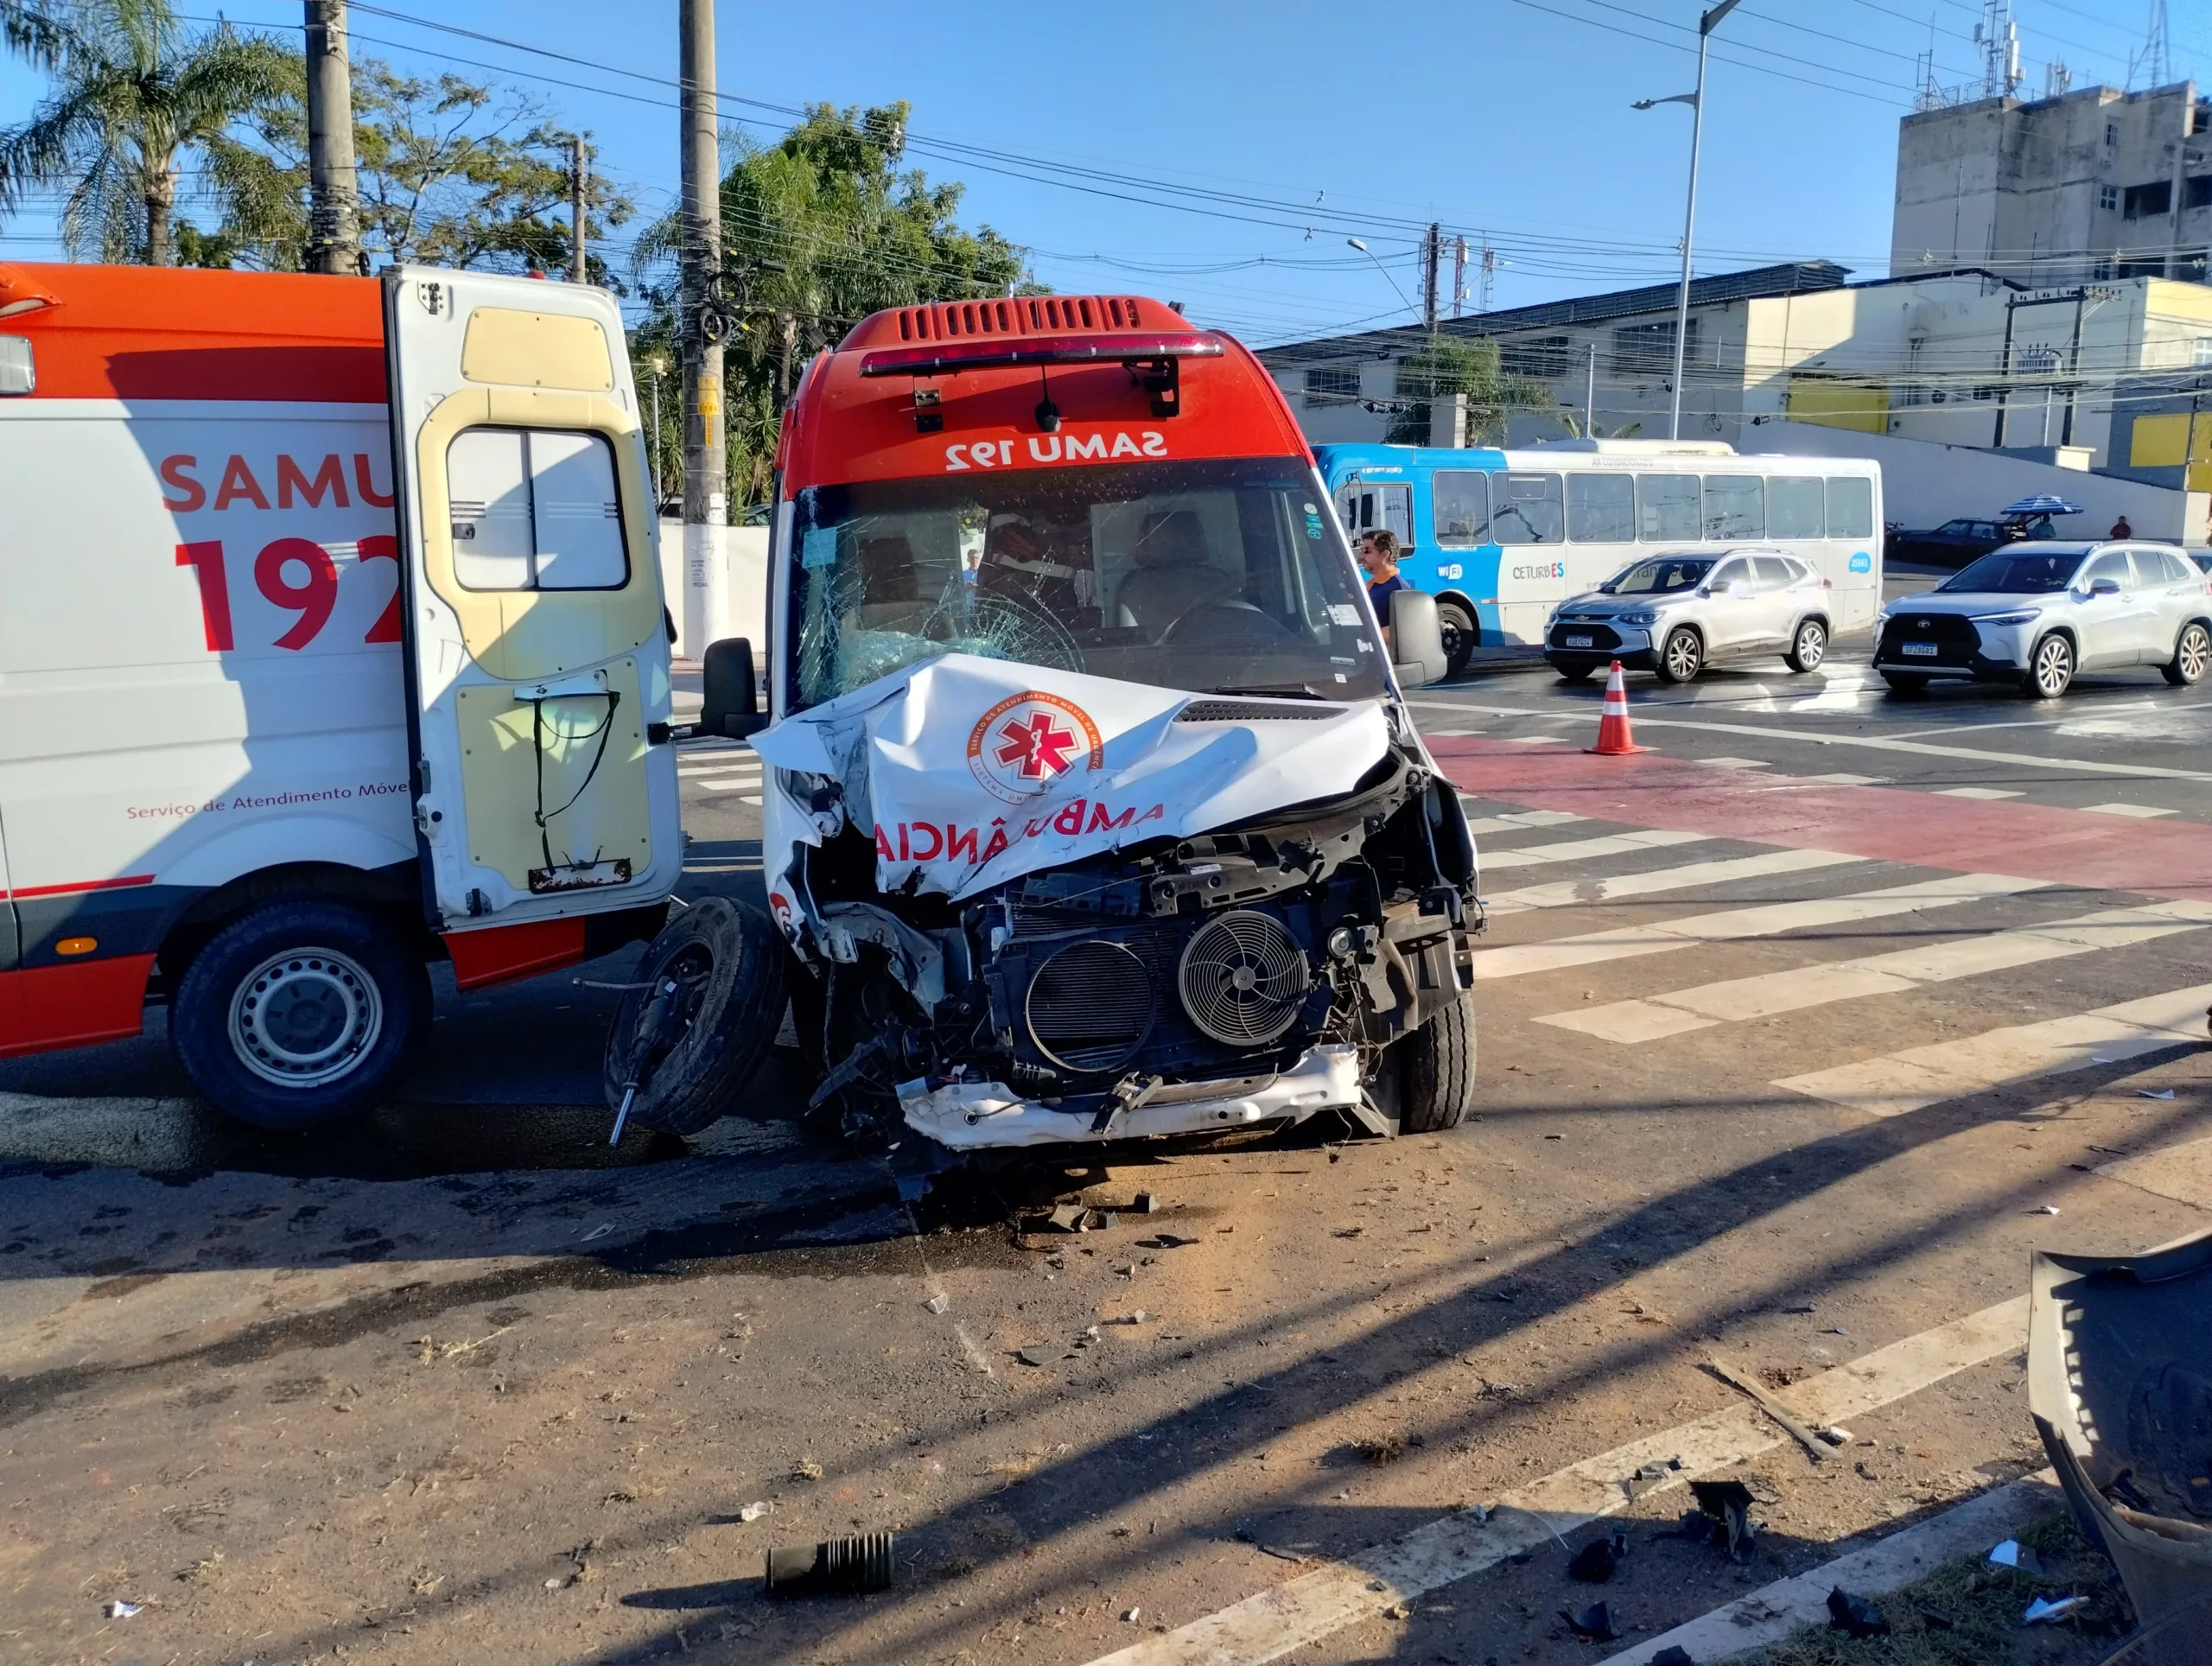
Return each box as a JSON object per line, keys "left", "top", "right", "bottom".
{"left": 752, "top": 652, "right": 1389, "bottom": 899}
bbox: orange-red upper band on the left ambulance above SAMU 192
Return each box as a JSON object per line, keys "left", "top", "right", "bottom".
{"left": 0, "top": 264, "right": 385, "bottom": 405}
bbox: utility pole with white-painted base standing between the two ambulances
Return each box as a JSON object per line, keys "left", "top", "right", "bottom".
{"left": 677, "top": 0, "right": 730, "bottom": 659}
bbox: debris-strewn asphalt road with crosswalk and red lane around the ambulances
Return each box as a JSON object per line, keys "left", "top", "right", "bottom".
{"left": 0, "top": 588, "right": 2212, "bottom": 1666}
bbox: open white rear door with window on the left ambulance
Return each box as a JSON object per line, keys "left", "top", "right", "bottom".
{"left": 385, "top": 268, "right": 683, "bottom": 946}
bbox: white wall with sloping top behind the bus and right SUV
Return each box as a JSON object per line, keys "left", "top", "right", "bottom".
{"left": 1737, "top": 423, "right": 2212, "bottom": 544}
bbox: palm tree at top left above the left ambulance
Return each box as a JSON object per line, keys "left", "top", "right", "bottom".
{"left": 0, "top": 0, "right": 299, "bottom": 265}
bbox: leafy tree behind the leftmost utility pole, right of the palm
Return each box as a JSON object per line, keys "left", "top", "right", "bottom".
{"left": 187, "top": 63, "right": 635, "bottom": 289}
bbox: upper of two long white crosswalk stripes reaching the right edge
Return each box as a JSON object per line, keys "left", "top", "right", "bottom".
{"left": 1535, "top": 903, "right": 2212, "bottom": 1042}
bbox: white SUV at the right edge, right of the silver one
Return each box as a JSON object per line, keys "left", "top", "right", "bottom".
{"left": 1873, "top": 542, "right": 2212, "bottom": 699}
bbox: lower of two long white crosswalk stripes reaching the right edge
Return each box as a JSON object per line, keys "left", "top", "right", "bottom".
{"left": 1774, "top": 984, "right": 2212, "bottom": 1117}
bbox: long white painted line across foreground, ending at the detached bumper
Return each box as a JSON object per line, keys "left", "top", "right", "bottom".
{"left": 1090, "top": 1296, "right": 2029, "bottom": 1666}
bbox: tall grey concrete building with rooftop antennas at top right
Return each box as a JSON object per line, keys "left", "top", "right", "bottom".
{"left": 1889, "top": 82, "right": 2212, "bottom": 288}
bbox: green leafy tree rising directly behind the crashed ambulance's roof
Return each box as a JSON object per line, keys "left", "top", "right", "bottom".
{"left": 632, "top": 102, "right": 1038, "bottom": 500}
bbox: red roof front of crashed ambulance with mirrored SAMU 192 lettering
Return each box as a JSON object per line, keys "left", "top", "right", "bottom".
{"left": 777, "top": 295, "right": 1310, "bottom": 496}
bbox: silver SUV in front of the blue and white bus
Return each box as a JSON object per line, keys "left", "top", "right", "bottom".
{"left": 1544, "top": 549, "right": 1829, "bottom": 684}
